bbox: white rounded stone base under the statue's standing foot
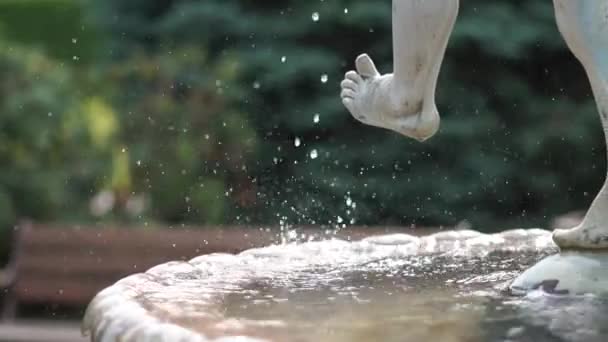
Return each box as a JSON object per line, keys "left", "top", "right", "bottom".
{"left": 510, "top": 251, "right": 608, "bottom": 295}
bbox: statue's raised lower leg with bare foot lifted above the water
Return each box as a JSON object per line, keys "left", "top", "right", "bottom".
{"left": 341, "top": 0, "right": 459, "bottom": 141}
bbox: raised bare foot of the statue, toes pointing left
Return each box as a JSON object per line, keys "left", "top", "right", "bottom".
{"left": 340, "top": 54, "right": 440, "bottom": 141}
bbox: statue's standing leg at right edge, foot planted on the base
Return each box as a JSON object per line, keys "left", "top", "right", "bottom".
{"left": 553, "top": 0, "right": 608, "bottom": 249}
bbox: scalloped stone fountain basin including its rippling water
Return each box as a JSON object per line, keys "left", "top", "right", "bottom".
{"left": 85, "top": 231, "right": 608, "bottom": 342}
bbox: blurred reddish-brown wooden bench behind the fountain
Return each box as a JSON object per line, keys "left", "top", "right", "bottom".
{"left": 0, "top": 223, "right": 273, "bottom": 320}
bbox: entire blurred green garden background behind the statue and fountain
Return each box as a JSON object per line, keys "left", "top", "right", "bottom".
{"left": 0, "top": 0, "right": 605, "bottom": 243}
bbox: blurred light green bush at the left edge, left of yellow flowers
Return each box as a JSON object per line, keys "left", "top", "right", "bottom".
{"left": 0, "top": 42, "right": 103, "bottom": 228}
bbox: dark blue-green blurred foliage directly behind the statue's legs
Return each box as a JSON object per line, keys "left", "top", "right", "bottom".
{"left": 86, "top": 0, "right": 604, "bottom": 229}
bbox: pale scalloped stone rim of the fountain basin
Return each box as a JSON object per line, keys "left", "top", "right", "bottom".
{"left": 82, "top": 229, "right": 554, "bottom": 342}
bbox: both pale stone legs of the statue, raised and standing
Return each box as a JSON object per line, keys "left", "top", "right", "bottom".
{"left": 341, "top": 0, "right": 608, "bottom": 250}
